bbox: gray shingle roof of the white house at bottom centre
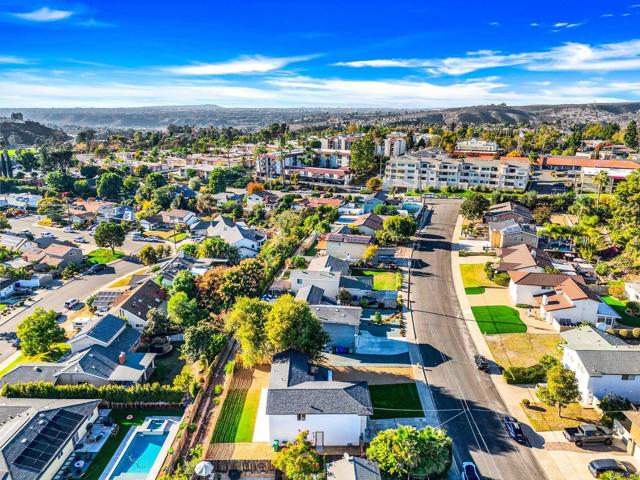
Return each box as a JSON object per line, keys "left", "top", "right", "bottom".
{"left": 266, "top": 350, "right": 373, "bottom": 415}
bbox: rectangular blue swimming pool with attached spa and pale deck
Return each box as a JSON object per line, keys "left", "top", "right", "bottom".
{"left": 100, "top": 416, "right": 180, "bottom": 480}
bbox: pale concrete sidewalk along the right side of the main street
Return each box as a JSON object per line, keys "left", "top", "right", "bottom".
{"left": 451, "top": 216, "right": 564, "bottom": 480}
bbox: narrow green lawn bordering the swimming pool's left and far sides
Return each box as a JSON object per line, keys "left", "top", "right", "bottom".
{"left": 82, "top": 409, "right": 184, "bottom": 480}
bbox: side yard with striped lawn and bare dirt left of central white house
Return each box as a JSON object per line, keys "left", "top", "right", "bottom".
{"left": 212, "top": 368, "right": 269, "bottom": 443}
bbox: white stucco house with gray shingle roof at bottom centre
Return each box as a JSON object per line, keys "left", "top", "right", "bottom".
{"left": 253, "top": 350, "right": 373, "bottom": 447}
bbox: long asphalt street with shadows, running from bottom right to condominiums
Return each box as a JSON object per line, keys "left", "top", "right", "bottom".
{"left": 410, "top": 200, "right": 546, "bottom": 480}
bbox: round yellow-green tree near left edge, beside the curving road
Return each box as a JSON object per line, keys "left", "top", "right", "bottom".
{"left": 17, "top": 307, "right": 64, "bottom": 357}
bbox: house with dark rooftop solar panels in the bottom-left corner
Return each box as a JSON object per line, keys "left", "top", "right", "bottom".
{"left": 0, "top": 398, "right": 100, "bottom": 480}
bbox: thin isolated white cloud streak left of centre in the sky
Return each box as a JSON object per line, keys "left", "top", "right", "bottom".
{"left": 162, "top": 55, "right": 313, "bottom": 76}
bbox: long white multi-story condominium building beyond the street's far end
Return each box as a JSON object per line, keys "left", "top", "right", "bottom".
{"left": 384, "top": 150, "right": 529, "bottom": 190}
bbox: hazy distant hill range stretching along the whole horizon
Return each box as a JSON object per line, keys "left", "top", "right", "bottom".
{"left": 0, "top": 102, "right": 640, "bottom": 130}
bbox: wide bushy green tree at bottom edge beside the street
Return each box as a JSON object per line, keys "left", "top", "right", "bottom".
{"left": 367, "top": 426, "right": 452, "bottom": 478}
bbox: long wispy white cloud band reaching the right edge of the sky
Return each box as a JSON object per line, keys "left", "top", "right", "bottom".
{"left": 334, "top": 40, "right": 640, "bottom": 75}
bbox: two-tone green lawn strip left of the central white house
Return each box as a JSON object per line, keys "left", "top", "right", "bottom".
{"left": 212, "top": 382, "right": 260, "bottom": 443}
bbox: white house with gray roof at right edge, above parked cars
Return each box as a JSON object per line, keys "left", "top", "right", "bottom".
{"left": 561, "top": 326, "right": 640, "bottom": 405}
